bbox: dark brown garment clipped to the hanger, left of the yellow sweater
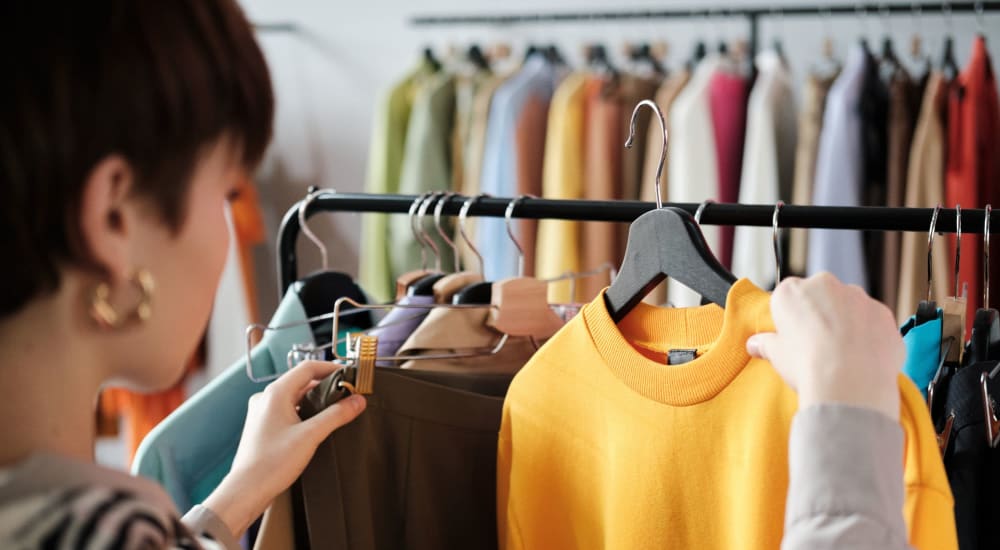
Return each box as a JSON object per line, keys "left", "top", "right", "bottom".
{"left": 293, "top": 367, "right": 513, "bottom": 550}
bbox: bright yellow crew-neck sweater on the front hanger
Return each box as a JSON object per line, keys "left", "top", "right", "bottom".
{"left": 497, "top": 280, "right": 957, "bottom": 550}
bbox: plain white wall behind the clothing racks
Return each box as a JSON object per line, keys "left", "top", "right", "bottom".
{"left": 241, "top": 0, "right": 1000, "bottom": 315}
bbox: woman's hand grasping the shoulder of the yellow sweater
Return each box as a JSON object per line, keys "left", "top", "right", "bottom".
{"left": 747, "top": 273, "right": 906, "bottom": 420}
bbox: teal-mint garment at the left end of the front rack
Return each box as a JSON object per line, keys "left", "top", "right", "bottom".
{"left": 132, "top": 284, "right": 357, "bottom": 514}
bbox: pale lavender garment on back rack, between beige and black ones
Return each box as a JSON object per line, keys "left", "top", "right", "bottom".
{"left": 806, "top": 45, "right": 869, "bottom": 291}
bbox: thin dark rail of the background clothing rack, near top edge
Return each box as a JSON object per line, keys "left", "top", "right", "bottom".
{"left": 410, "top": 2, "right": 1000, "bottom": 64}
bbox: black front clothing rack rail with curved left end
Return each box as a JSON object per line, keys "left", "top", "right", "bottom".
{"left": 278, "top": 192, "right": 1000, "bottom": 294}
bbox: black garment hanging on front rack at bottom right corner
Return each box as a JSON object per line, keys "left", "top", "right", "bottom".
{"left": 934, "top": 362, "right": 1000, "bottom": 550}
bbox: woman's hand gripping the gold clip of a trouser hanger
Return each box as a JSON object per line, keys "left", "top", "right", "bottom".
{"left": 199, "top": 361, "right": 365, "bottom": 538}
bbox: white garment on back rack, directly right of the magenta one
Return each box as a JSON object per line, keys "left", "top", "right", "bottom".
{"left": 733, "top": 50, "right": 797, "bottom": 288}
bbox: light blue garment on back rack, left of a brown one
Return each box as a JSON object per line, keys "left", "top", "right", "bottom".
{"left": 476, "top": 54, "right": 558, "bottom": 281}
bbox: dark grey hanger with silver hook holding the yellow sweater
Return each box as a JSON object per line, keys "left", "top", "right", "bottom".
{"left": 604, "top": 99, "right": 736, "bottom": 323}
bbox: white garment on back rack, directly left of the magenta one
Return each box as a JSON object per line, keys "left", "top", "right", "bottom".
{"left": 667, "top": 54, "right": 722, "bottom": 307}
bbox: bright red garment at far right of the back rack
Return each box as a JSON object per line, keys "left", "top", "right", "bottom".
{"left": 945, "top": 36, "right": 1000, "bottom": 326}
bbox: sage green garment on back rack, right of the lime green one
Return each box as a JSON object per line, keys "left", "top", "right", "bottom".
{"left": 389, "top": 73, "right": 455, "bottom": 280}
